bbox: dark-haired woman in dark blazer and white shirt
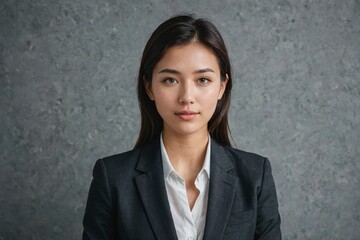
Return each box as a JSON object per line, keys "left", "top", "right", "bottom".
{"left": 83, "top": 15, "right": 281, "bottom": 240}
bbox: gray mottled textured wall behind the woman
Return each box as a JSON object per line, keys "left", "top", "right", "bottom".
{"left": 0, "top": 0, "right": 360, "bottom": 240}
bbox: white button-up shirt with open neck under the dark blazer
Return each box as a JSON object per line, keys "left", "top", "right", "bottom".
{"left": 160, "top": 135, "right": 211, "bottom": 240}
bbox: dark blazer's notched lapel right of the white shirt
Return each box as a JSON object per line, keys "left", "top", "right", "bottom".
{"left": 204, "top": 140, "right": 238, "bottom": 239}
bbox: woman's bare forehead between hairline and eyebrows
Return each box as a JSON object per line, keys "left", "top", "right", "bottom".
{"left": 154, "top": 42, "right": 220, "bottom": 73}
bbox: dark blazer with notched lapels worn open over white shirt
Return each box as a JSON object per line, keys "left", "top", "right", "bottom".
{"left": 83, "top": 138, "right": 281, "bottom": 240}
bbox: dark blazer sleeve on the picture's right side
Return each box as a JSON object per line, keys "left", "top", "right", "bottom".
{"left": 255, "top": 159, "right": 281, "bottom": 240}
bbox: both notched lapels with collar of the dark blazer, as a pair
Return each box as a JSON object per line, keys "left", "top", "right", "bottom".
{"left": 135, "top": 138, "right": 238, "bottom": 239}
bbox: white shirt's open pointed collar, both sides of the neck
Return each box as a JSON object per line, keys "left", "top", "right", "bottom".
{"left": 160, "top": 133, "right": 211, "bottom": 179}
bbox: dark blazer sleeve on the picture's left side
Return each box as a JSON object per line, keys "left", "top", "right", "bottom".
{"left": 82, "top": 159, "right": 116, "bottom": 240}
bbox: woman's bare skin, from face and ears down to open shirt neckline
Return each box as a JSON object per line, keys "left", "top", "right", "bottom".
{"left": 146, "top": 42, "right": 227, "bottom": 209}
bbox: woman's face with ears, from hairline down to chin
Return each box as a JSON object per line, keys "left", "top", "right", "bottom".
{"left": 146, "top": 43, "right": 227, "bottom": 138}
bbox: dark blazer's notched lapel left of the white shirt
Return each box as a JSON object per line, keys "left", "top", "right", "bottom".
{"left": 135, "top": 138, "right": 177, "bottom": 240}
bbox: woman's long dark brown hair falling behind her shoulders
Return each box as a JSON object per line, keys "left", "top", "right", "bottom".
{"left": 135, "top": 15, "right": 232, "bottom": 148}
